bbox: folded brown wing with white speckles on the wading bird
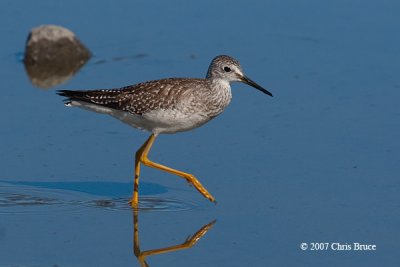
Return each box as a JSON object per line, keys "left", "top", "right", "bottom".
{"left": 58, "top": 78, "right": 203, "bottom": 115}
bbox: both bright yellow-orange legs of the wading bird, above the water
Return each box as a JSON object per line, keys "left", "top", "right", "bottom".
{"left": 130, "top": 134, "right": 215, "bottom": 208}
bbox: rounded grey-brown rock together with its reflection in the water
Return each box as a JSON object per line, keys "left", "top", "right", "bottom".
{"left": 24, "top": 25, "right": 91, "bottom": 88}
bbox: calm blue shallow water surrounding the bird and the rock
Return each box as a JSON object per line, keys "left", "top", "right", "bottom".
{"left": 0, "top": 0, "right": 400, "bottom": 267}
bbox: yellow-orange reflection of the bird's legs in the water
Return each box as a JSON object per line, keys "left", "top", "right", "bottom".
{"left": 133, "top": 209, "right": 216, "bottom": 267}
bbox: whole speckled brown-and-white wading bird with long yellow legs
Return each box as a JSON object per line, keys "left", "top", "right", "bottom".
{"left": 58, "top": 55, "right": 272, "bottom": 207}
